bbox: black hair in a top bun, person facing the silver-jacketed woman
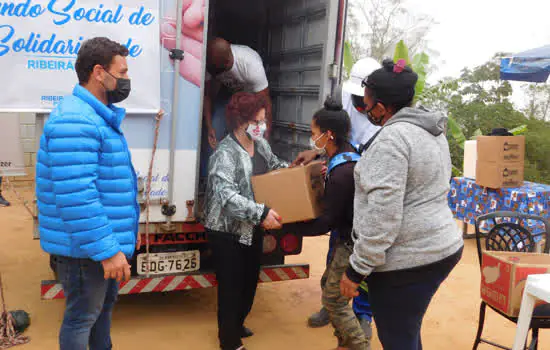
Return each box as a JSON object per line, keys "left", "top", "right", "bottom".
{"left": 313, "top": 96, "right": 351, "bottom": 147}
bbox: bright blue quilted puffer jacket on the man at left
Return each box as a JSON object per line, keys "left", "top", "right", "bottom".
{"left": 36, "top": 85, "right": 140, "bottom": 261}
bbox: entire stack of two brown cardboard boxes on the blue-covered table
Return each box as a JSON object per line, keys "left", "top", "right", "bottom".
{"left": 475, "top": 136, "right": 525, "bottom": 188}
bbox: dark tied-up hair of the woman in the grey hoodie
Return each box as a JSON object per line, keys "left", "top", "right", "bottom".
{"left": 363, "top": 59, "right": 418, "bottom": 112}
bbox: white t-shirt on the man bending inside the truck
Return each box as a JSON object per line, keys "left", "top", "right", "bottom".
{"left": 206, "top": 44, "right": 268, "bottom": 93}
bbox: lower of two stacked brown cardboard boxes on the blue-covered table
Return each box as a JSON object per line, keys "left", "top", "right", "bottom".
{"left": 476, "top": 161, "right": 524, "bottom": 188}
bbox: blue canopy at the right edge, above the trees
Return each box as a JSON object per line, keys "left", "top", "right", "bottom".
{"left": 500, "top": 45, "right": 550, "bottom": 83}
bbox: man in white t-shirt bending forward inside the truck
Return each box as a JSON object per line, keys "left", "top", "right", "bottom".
{"left": 201, "top": 38, "right": 272, "bottom": 176}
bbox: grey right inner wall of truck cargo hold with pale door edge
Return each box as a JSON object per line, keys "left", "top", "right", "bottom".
{"left": 267, "top": 0, "right": 347, "bottom": 160}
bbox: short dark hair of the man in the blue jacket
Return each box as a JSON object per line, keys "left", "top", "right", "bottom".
{"left": 75, "top": 37, "right": 128, "bottom": 84}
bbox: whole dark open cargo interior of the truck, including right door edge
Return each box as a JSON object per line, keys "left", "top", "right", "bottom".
{"left": 209, "top": 0, "right": 347, "bottom": 161}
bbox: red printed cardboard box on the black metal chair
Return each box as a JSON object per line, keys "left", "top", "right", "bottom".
{"left": 481, "top": 251, "right": 550, "bottom": 317}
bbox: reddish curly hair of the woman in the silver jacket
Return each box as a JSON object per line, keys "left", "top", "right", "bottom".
{"left": 225, "top": 92, "right": 267, "bottom": 131}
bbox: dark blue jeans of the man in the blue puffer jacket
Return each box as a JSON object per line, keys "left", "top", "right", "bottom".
{"left": 56, "top": 257, "right": 118, "bottom": 350}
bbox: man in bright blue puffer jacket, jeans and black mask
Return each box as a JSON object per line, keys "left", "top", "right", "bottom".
{"left": 36, "top": 38, "right": 140, "bottom": 350}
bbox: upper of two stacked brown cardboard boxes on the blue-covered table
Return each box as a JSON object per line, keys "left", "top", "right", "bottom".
{"left": 477, "top": 136, "right": 525, "bottom": 164}
